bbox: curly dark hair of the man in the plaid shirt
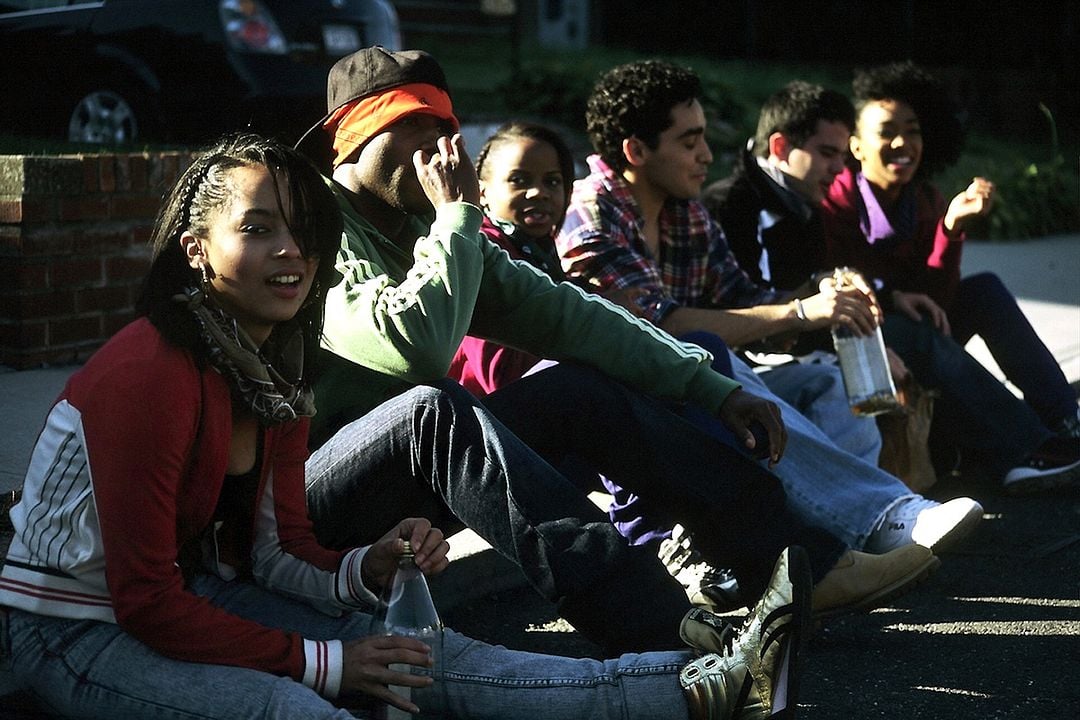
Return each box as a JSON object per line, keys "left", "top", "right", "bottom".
{"left": 585, "top": 60, "right": 702, "bottom": 172}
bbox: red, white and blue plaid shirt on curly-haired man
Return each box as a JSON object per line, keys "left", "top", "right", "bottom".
{"left": 555, "top": 155, "right": 780, "bottom": 324}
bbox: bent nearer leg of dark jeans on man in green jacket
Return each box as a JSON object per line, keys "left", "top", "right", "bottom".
{"left": 306, "top": 380, "right": 691, "bottom": 654}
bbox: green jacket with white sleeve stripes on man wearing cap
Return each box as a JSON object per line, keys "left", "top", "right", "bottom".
{"left": 311, "top": 185, "right": 739, "bottom": 445}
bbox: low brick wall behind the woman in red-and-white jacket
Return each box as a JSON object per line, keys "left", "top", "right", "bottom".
{"left": 0, "top": 152, "right": 191, "bottom": 369}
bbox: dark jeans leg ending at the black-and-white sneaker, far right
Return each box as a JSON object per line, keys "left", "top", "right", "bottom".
{"left": 881, "top": 297, "right": 1049, "bottom": 475}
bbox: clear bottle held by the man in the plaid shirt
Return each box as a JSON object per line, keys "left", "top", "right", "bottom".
{"left": 833, "top": 268, "right": 901, "bottom": 416}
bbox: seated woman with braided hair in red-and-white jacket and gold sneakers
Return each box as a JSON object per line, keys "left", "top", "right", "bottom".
{"left": 0, "top": 135, "right": 810, "bottom": 720}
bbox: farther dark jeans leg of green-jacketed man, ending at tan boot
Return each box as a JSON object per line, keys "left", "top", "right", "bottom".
{"left": 484, "top": 363, "right": 845, "bottom": 597}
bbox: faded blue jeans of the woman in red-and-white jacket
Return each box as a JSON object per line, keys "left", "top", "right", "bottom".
{"left": 10, "top": 575, "right": 689, "bottom": 720}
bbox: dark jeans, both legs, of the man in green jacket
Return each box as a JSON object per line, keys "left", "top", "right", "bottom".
{"left": 307, "top": 377, "right": 842, "bottom": 653}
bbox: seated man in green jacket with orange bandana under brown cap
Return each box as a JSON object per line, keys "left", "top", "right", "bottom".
{"left": 298, "top": 47, "right": 935, "bottom": 651}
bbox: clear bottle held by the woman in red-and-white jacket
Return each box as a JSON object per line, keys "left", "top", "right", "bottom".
{"left": 370, "top": 541, "right": 443, "bottom": 720}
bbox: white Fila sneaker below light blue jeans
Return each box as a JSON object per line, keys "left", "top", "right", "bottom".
{"left": 863, "top": 497, "right": 983, "bottom": 554}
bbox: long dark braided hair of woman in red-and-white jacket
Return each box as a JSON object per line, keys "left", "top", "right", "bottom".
{"left": 136, "top": 133, "right": 342, "bottom": 379}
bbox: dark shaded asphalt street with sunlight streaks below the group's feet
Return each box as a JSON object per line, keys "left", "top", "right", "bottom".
{"left": 445, "top": 474, "right": 1080, "bottom": 720}
